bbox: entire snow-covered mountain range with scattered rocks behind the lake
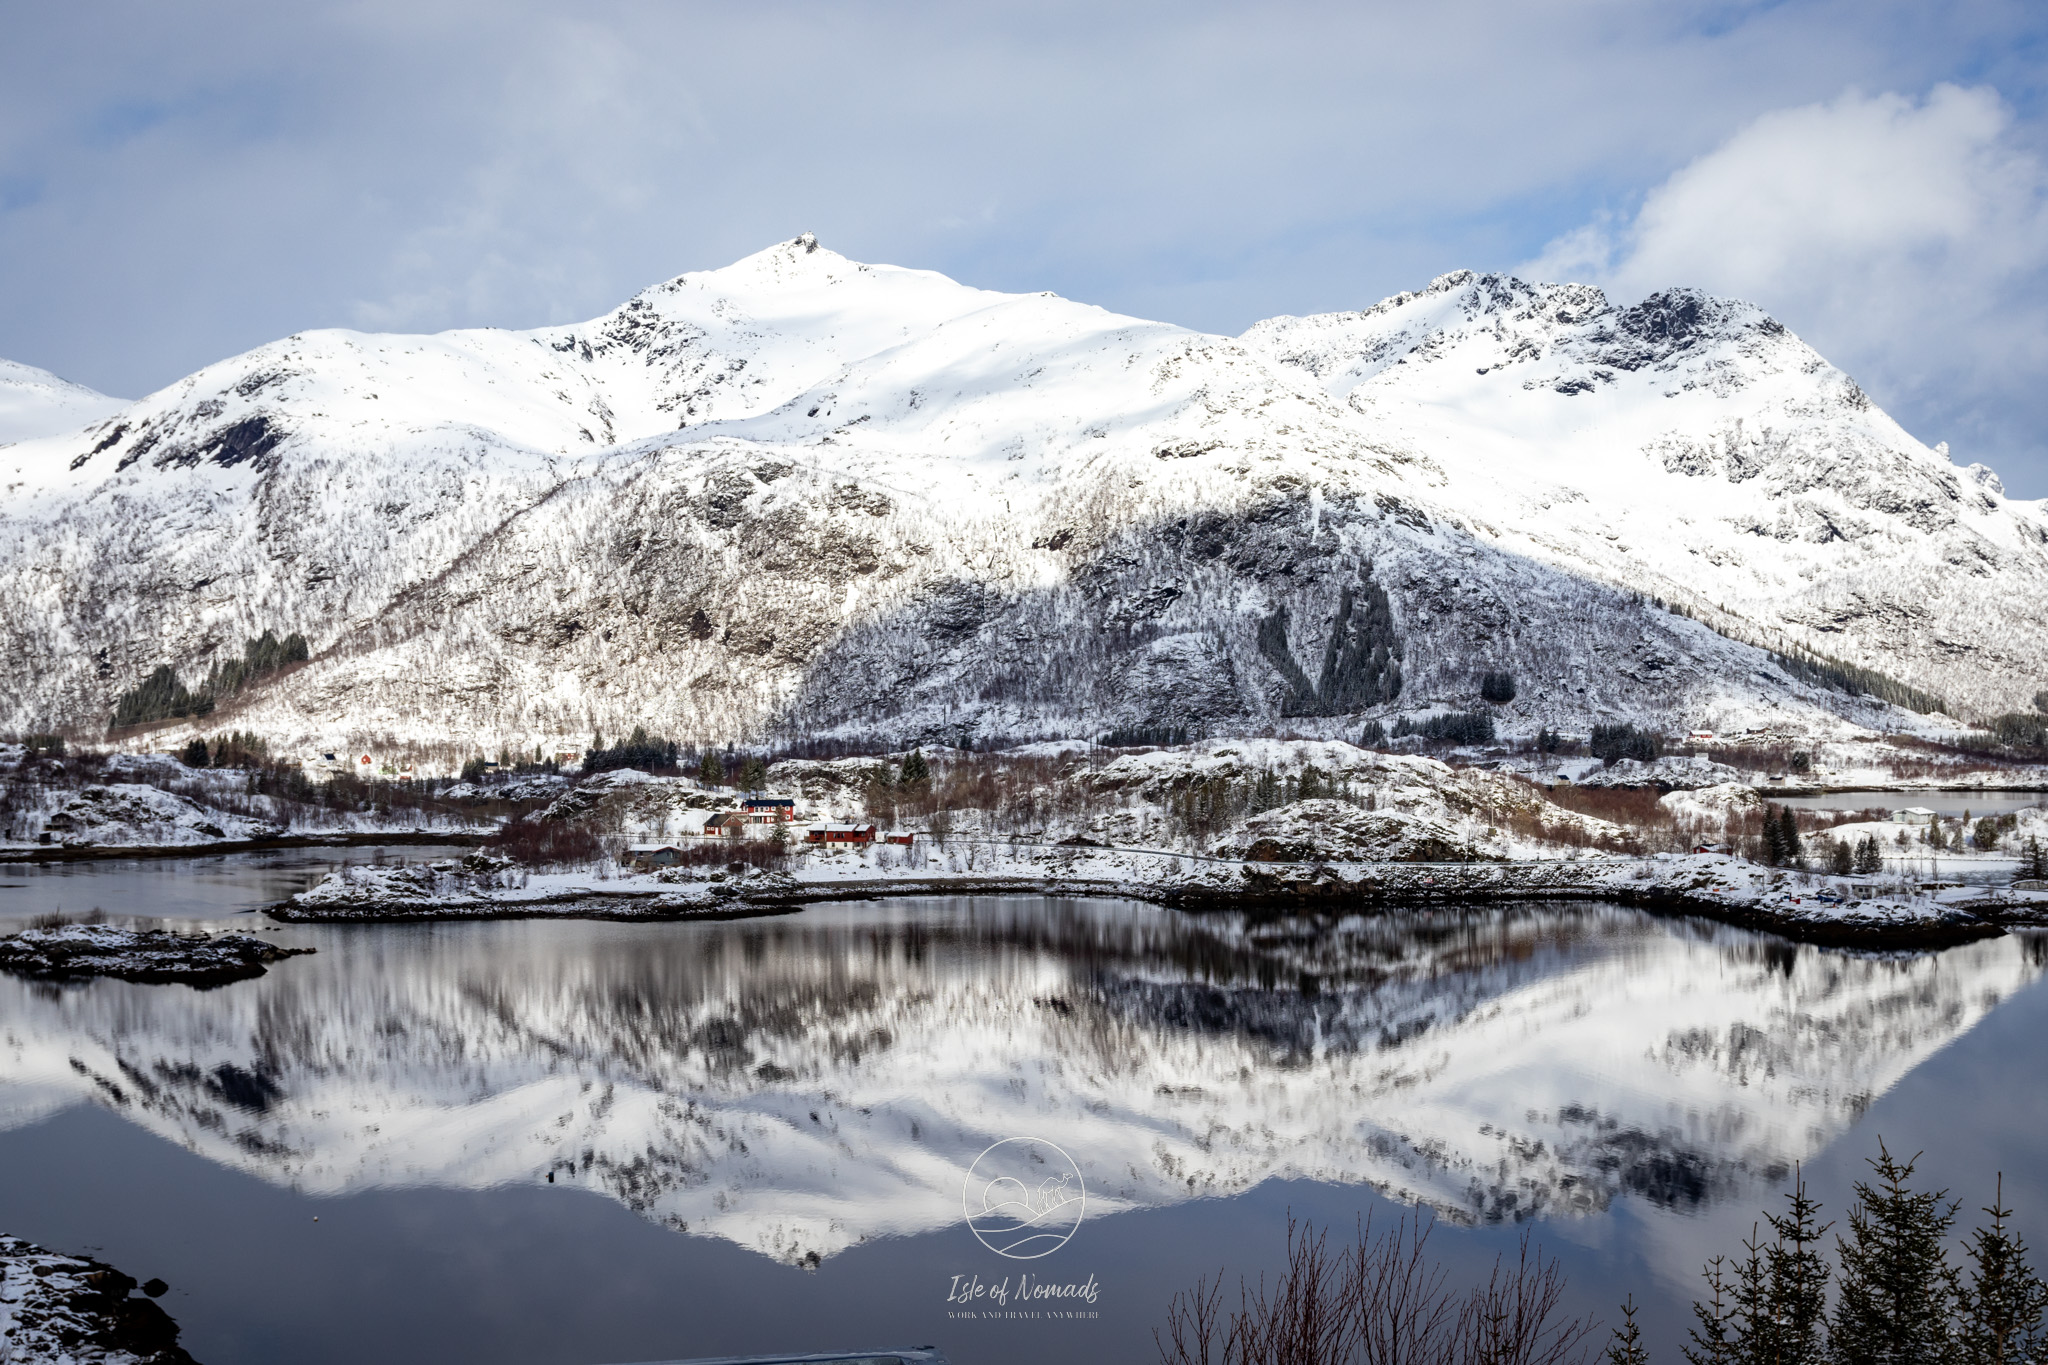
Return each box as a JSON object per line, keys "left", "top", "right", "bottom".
{"left": 0, "top": 237, "right": 2048, "bottom": 743}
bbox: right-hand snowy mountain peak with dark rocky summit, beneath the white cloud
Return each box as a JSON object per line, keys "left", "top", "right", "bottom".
{"left": 1245, "top": 270, "right": 2048, "bottom": 708}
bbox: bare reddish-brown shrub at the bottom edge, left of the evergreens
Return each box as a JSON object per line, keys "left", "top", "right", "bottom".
{"left": 1153, "top": 1216, "right": 1597, "bottom": 1365}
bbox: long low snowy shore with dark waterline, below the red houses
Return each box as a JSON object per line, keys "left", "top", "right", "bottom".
{"left": 270, "top": 841, "right": 2048, "bottom": 950}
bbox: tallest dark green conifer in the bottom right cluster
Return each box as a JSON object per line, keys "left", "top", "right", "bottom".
{"left": 1833, "top": 1142, "right": 1962, "bottom": 1365}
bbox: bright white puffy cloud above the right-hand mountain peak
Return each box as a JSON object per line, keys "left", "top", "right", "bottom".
{"left": 1522, "top": 84, "right": 2048, "bottom": 491}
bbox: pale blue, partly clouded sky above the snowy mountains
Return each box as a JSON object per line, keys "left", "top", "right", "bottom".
{"left": 12, "top": 0, "right": 2048, "bottom": 497}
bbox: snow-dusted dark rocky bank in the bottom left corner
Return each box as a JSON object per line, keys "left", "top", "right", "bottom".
{"left": 0, "top": 1236, "right": 195, "bottom": 1365}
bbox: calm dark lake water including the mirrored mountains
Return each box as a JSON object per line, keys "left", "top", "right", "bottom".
{"left": 0, "top": 849, "right": 2048, "bottom": 1365}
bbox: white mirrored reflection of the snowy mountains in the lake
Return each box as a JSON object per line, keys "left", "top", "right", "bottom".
{"left": 0, "top": 898, "right": 2042, "bottom": 1263}
